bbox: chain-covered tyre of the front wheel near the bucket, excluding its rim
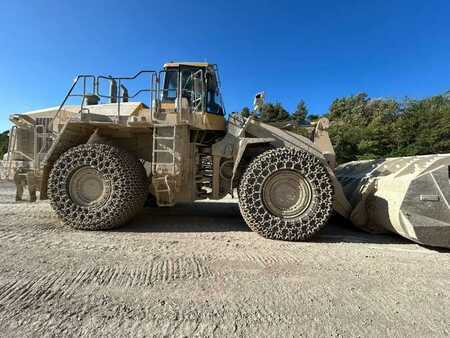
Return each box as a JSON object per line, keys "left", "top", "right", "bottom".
{"left": 239, "top": 148, "right": 334, "bottom": 241}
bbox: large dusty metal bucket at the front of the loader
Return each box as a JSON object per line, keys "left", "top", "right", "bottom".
{"left": 336, "top": 154, "right": 450, "bottom": 248}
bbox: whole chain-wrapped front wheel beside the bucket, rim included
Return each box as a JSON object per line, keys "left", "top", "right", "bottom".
{"left": 239, "top": 148, "right": 334, "bottom": 241}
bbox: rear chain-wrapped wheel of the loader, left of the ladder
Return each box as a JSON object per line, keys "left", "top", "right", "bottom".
{"left": 48, "top": 144, "right": 148, "bottom": 230}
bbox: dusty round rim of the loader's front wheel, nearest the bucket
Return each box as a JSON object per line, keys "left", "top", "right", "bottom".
{"left": 262, "top": 170, "right": 313, "bottom": 218}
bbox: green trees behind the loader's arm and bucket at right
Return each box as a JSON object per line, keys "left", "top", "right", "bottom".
{"left": 237, "top": 91, "right": 450, "bottom": 163}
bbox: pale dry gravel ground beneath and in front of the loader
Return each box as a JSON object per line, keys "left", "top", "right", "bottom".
{"left": 0, "top": 183, "right": 450, "bottom": 337}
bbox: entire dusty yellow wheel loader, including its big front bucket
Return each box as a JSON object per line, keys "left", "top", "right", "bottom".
{"left": 6, "top": 62, "right": 450, "bottom": 247}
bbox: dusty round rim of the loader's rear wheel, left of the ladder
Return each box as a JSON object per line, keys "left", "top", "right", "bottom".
{"left": 69, "top": 167, "right": 111, "bottom": 206}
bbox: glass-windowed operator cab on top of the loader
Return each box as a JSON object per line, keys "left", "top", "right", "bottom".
{"left": 160, "top": 62, "right": 224, "bottom": 123}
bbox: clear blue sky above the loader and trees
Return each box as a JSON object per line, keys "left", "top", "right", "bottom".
{"left": 0, "top": 0, "right": 450, "bottom": 130}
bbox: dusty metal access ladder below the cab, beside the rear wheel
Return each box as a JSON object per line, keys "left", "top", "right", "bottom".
{"left": 152, "top": 124, "right": 176, "bottom": 207}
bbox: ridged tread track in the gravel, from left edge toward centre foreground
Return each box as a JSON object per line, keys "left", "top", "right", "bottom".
{"left": 0, "top": 256, "right": 213, "bottom": 306}
